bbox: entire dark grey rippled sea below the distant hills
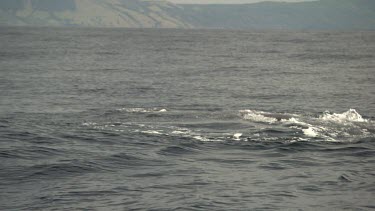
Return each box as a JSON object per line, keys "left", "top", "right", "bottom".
{"left": 0, "top": 28, "right": 375, "bottom": 210}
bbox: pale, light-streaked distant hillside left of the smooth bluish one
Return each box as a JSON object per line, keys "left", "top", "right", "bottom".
{"left": 0, "top": 0, "right": 193, "bottom": 28}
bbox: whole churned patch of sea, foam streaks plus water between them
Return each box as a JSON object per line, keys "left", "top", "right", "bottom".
{"left": 82, "top": 108, "right": 375, "bottom": 143}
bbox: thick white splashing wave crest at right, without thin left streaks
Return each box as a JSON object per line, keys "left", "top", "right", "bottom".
{"left": 240, "top": 109, "right": 375, "bottom": 142}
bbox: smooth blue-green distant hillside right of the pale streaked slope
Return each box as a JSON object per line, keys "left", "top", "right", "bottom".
{"left": 183, "top": 0, "right": 375, "bottom": 30}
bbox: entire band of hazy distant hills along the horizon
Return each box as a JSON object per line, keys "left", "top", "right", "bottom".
{"left": 0, "top": 0, "right": 375, "bottom": 30}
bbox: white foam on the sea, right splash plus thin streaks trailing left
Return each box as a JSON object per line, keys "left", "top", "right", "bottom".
{"left": 86, "top": 108, "right": 375, "bottom": 142}
